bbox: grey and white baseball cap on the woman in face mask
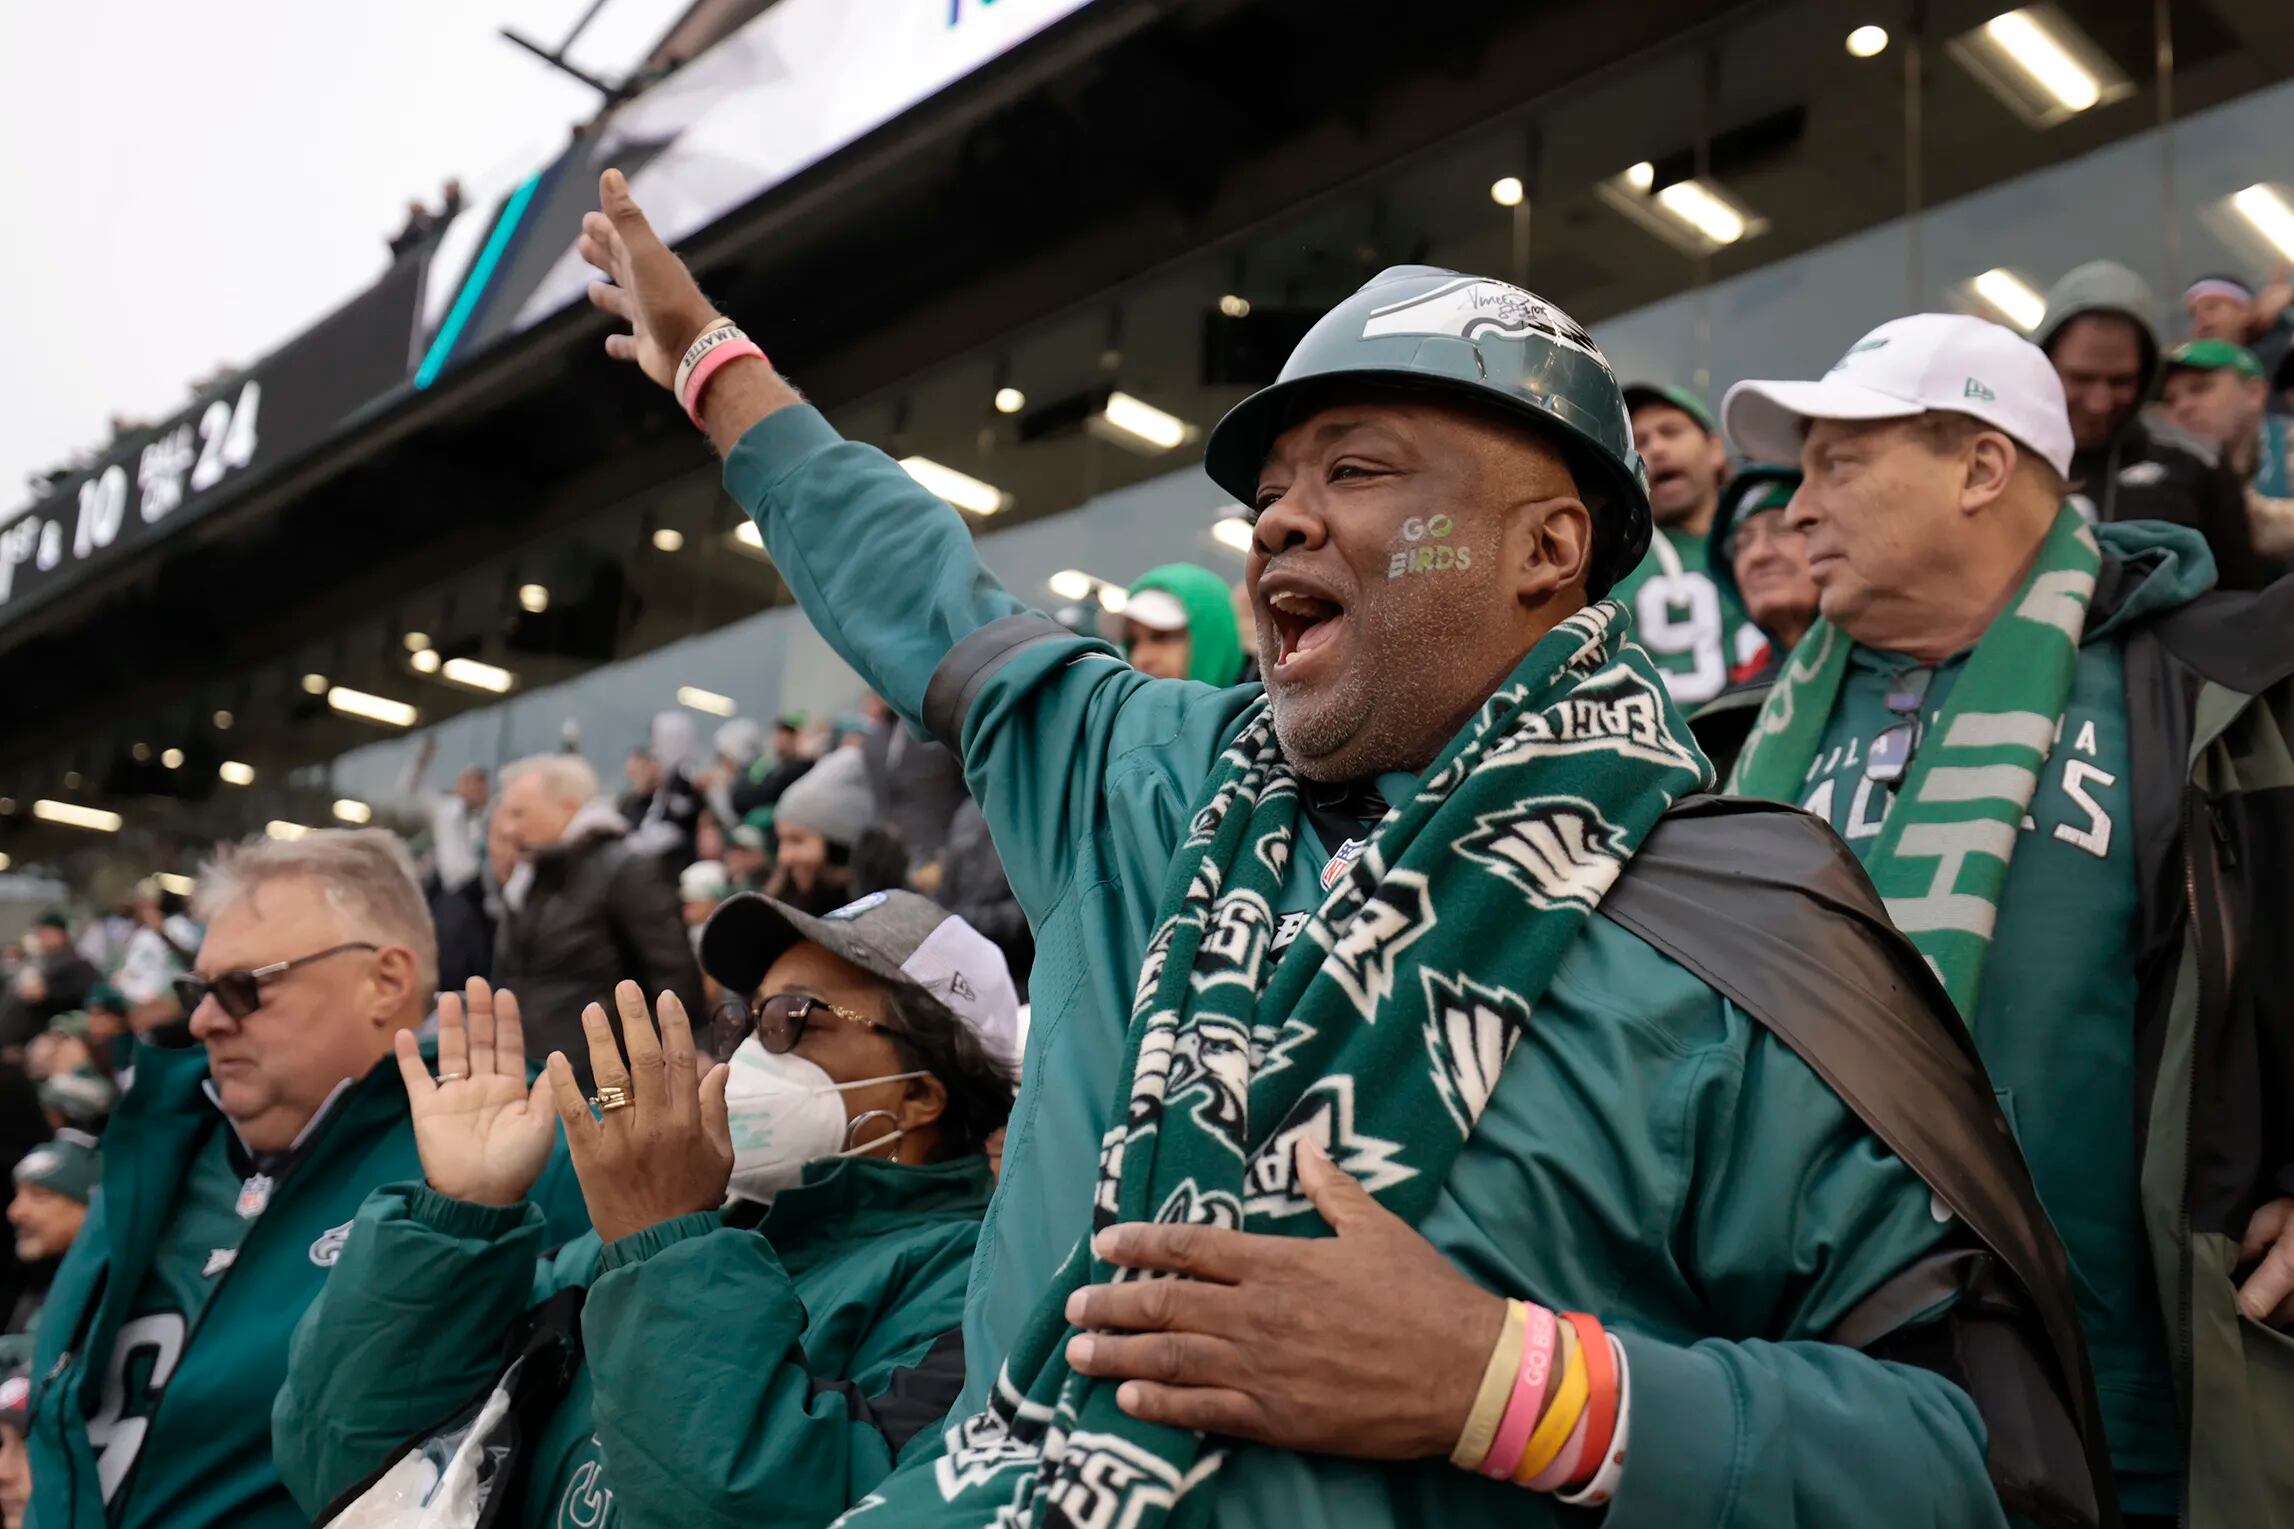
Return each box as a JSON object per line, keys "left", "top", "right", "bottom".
{"left": 702, "top": 892, "right": 1019, "bottom": 1068}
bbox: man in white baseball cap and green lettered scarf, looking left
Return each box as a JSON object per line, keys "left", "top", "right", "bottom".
{"left": 1721, "top": 314, "right": 2294, "bottom": 1524}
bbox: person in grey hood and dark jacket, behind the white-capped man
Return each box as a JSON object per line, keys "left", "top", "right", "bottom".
{"left": 2032, "top": 259, "right": 2287, "bottom": 589}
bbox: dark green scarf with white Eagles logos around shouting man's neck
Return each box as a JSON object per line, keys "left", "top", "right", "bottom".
{"left": 840, "top": 601, "right": 1711, "bottom": 1529}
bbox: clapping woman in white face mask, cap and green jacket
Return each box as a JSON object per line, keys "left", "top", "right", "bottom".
{"left": 273, "top": 892, "right": 1016, "bottom": 1529}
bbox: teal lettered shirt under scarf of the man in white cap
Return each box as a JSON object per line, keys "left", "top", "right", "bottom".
{"left": 1798, "top": 637, "right": 2182, "bottom": 1513}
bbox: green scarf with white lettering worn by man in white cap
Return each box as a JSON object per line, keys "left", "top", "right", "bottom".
{"left": 1727, "top": 504, "right": 2101, "bottom": 1020}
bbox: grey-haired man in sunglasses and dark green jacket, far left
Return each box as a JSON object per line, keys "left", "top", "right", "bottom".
{"left": 28, "top": 830, "right": 585, "bottom": 1529}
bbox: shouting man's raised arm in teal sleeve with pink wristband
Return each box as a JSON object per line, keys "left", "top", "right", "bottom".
{"left": 580, "top": 170, "right": 1253, "bottom": 919}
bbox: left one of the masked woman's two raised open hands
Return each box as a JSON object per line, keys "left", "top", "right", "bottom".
{"left": 397, "top": 977, "right": 557, "bottom": 1206}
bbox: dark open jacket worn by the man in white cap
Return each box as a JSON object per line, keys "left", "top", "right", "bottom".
{"left": 1695, "top": 523, "right": 2294, "bottom": 1529}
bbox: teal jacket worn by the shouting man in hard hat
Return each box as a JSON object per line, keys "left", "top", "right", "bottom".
{"left": 725, "top": 408, "right": 2000, "bottom": 1529}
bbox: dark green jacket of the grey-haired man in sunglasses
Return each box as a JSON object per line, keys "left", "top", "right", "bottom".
{"left": 25, "top": 1045, "right": 587, "bottom": 1529}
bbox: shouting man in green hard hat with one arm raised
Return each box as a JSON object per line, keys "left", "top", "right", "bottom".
{"left": 583, "top": 172, "right": 2085, "bottom": 1529}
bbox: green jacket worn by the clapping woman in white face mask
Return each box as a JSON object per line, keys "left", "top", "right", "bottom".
{"left": 273, "top": 1155, "right": 993, "bottom": 1529}
